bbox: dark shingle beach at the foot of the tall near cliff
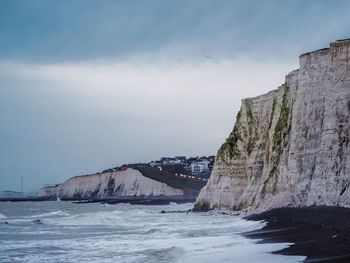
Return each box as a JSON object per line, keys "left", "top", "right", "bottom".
{"left": 243, "top": 206, "right": 350, "bottom": 263}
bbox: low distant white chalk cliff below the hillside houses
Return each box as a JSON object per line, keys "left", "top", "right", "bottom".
{"left": 39, "top": 168, "right": 184, "bottom": 198}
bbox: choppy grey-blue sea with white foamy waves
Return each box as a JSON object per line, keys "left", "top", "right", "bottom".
{"left": 0, "top": 201, "right": 305, "bottom": 263}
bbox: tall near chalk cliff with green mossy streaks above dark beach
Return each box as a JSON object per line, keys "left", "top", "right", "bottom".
{"left": 196, "top": 40, "right": 350, "bottom": 211}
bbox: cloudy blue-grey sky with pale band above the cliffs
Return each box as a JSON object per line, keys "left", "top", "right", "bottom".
{"left": 0, "top": 0, "right": 350, "bottom": 193}
